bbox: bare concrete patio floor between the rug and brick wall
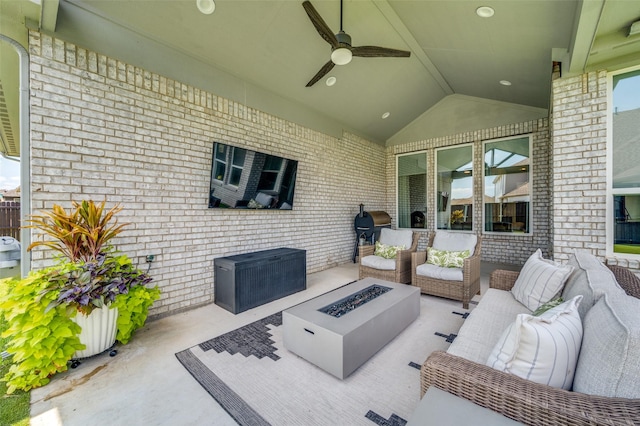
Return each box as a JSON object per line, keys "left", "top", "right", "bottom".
{"left": 31, "top": 263, "right": 512, "bottom": 426}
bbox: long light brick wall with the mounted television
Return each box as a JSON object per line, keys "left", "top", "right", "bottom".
{"left": 29, "top": 32, "right": 386, "bottom": 316}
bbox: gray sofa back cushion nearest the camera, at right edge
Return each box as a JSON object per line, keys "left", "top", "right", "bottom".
{"left": 573, "top": 294, "right": 640, "bottom": 399}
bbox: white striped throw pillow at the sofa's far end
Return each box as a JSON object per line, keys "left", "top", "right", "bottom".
{"left": 511, "top": 249, "right": 573, "bottom": 311}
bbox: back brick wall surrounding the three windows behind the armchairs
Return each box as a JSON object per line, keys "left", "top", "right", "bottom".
{"left": 386, "top": 119, "right": 553, "bottom": 265}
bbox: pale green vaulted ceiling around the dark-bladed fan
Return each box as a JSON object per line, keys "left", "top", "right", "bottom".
{"left": 0, "top": 0, "right": 640, "bottom": 155}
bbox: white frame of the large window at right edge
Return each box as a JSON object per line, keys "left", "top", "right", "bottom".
{"left": 605, "top": 65, "right": 640, "bottom": 260}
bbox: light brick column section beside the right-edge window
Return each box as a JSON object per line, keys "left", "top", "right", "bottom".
{"left": 552, "top": 71, "right": 607, "bottom": 261}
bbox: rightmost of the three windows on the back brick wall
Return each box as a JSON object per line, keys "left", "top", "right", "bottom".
{"left": 483, "top": 136, "right": 531, "bottom": 233}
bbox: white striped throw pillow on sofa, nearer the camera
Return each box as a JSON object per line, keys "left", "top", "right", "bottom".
{"left": 486, "top": 296, "right": 582, "bottom": 390}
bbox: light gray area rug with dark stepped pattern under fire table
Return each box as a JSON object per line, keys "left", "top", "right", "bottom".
{"left": 176, "top": 295, "right": 473, "bottom": 426}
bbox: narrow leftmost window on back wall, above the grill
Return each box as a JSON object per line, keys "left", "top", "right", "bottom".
{"left": 396, "top": 152, "right": 427, "bottom": 228}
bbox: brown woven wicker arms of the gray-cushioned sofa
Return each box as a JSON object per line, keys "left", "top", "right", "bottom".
{"left": 420, "top": 270, "right": 640, "bottom": 426}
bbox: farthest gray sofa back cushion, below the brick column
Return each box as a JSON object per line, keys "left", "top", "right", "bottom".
{"left": 562, "top": 250, "right": 625, "bottom": 319}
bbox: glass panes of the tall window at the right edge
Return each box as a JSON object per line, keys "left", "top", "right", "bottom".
{"left": 608, "top": 69, "right": 640, "bottom": 255}
